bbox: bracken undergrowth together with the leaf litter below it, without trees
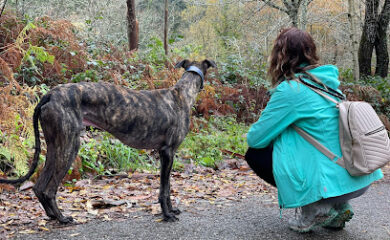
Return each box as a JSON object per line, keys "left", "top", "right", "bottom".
{"left": 0, "top": 12, "right": 390, "bottom": 238}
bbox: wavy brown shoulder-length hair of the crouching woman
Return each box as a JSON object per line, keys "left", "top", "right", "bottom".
{"left": 268, "top": 27, "right": 319, "bottom": 86}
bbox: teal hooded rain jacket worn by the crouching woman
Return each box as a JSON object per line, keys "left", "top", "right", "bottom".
{"left": 247, "top": 65, "right": 383, "bottom": 208}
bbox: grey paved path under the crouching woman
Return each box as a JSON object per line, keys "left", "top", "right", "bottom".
{"left": 15, "top": 182, "right": 390, "bottom": 240}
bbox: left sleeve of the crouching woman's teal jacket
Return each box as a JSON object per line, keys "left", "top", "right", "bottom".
{"left": 247, "top": 82, "right": 304, "bottom": 148}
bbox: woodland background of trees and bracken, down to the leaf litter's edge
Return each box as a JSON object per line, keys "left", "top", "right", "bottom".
{"left": 0, "top": 0, "right": 390, "bottom": 188}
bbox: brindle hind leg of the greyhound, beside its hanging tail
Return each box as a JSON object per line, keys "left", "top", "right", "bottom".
{"left": 33, "top": 106, "right": 81, "bottom": 223}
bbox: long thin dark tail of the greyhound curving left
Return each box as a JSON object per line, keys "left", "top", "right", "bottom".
{"left": 0, "top": 94, "right": 50, "bottom": 184}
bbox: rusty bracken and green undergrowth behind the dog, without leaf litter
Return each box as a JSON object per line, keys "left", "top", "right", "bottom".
{"left": 0, "top": 13, "right": 390, "bottom": 182}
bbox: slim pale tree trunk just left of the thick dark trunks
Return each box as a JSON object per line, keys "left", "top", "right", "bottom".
{"left": 348, "top": 0, "right": 360, "bottom": 81}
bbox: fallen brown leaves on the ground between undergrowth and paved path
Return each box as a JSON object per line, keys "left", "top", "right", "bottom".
{"left": 0, "top": 159, "right": 277, "bottom": 239}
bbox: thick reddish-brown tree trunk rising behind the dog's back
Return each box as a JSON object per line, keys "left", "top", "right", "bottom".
{"left": 126, "top": 0, "right": 138, "bottom": 51}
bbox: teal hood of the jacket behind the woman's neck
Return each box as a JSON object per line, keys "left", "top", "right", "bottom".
{"left": 308, "top": 65, "right": 340, "bottom": 89}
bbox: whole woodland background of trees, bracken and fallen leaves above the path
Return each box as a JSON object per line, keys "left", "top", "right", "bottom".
{"left": 0, "top": 0, "right": 390, "bottom": 238}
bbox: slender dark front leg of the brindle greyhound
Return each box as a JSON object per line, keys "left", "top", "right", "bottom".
{"left": 158, "top": 147, "right": 180, "bottom": 222}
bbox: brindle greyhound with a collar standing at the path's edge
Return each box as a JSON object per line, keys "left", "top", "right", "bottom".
{"left": 0, "top": 60, "right": 216, "bottom": 223}
